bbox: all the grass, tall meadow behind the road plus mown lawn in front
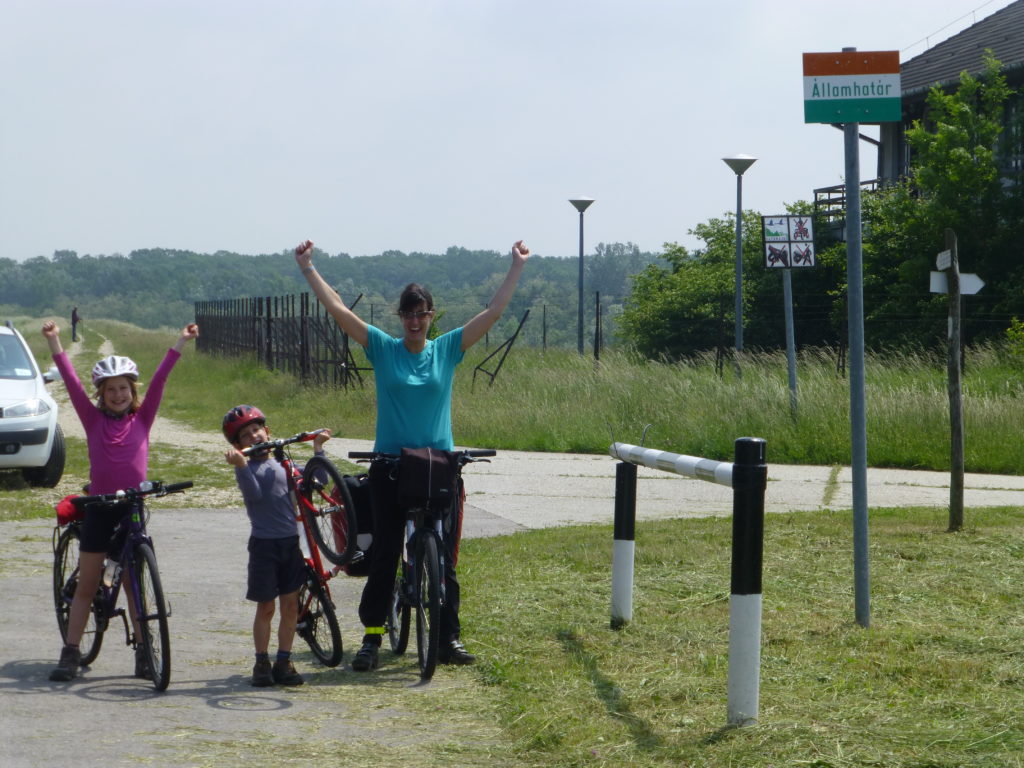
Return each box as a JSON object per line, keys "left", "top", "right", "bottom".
{"left": 0, "top": 323, "right": 1024, "bottom": 768}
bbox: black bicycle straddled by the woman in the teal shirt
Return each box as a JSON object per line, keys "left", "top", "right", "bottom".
{"left": 348, "top": 449, "right": 497, "bottom": 680}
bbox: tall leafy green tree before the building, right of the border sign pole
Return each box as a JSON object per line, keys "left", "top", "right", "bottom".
{"left": 864, "top": 52, "right": 1024, "bottom": 345}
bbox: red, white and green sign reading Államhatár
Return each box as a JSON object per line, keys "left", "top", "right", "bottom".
{"left": 804, "top": 50, "right": 903, "bottom": 123}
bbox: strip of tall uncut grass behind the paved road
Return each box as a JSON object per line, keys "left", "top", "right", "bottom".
{"left": 44, "top": 323, "right": 1024, "bottom": 474}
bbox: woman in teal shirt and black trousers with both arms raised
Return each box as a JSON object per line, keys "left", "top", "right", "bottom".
{"left": 295, "top": 240, "right": 529, "bottom": 672}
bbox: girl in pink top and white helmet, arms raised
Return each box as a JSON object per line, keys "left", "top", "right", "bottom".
{"left": 43, "top": 321, "right": 199, "bottom": 682}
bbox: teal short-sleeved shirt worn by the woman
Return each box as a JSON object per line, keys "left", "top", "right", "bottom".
{"left": 367, "top": 326, "right": 465, "bottom": 454}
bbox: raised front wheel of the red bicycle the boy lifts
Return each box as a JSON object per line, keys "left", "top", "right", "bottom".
{"left": 299, "top": 456, "right": 358, "bottom": 565}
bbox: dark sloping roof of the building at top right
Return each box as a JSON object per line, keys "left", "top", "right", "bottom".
{"left": 900, "top": 0, "right": 1024, "bottom": 96}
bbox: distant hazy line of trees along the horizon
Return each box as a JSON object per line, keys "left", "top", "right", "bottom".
{"left": 0, "top": 243, "right": 662, "bottom": 346}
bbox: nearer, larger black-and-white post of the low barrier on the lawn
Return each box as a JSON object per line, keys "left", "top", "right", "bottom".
{"left": 728, "top": 437, "right": 768, "bottom": 726}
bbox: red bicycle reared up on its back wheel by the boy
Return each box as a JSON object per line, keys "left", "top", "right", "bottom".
{"left": 242, "top": 429, "right": 361, "bottom": 667}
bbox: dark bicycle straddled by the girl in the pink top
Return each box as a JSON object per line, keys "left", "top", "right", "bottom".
{"left": 53, "top": 480, "right": 193, "bottom": 690}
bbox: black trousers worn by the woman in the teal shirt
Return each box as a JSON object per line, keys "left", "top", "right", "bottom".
{"left": 359, "top": 462, "right": 462, "bottom": 646}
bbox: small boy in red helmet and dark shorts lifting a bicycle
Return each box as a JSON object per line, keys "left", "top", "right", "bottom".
{"left": 221, "top": 406, "right": 331, "bottom": 688}
